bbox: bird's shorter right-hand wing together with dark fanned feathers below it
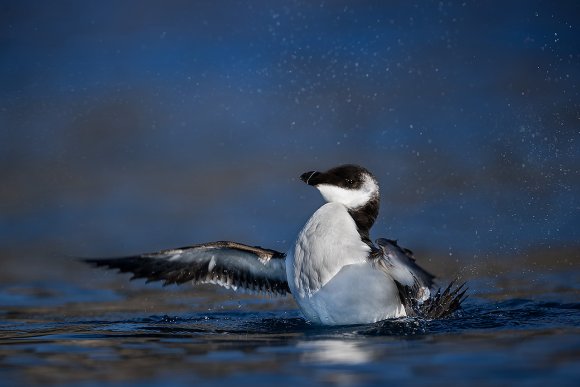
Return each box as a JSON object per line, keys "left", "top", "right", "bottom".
{"left": 370, "top": 238, "right": 467, "bottom": 318}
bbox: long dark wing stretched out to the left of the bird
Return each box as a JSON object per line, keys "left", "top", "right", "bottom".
{"left": 84, "top": 241, "right": 290, "bottom": 295}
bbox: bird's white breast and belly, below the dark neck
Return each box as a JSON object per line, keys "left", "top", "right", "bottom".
{"left": 286, "top": 203, "right": 405, "bottom": 325}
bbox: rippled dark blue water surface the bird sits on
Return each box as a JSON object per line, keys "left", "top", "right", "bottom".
{"left": 0, "top": 263, "right": 580, "bottom": 386}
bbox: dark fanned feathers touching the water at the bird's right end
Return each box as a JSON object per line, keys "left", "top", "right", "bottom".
{"left": 397, "top": 281, "right": 468, "bottom": 319}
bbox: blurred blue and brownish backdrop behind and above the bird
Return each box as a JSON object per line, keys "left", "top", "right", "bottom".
{"left": 0, "top": 0, "right": 580, "bottom": 282}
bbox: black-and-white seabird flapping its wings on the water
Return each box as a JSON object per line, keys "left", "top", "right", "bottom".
{"left": 85, "top": 165, "right": 466, "bottom": 325}
